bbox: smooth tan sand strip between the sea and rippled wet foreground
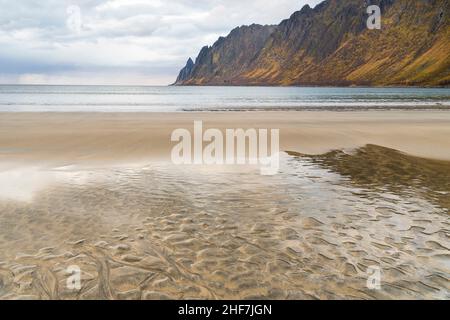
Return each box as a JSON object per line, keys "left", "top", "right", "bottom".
{"left": 0, "top": 111, "right": 450, "bottom": 164}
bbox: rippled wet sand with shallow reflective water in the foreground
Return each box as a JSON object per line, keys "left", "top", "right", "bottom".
{"left": 0, "top": 146, "right": 450, "bottom": 299}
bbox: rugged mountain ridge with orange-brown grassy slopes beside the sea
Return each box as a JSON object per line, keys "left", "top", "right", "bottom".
{"left": 175, "top": 0, "right": 450, "bottom": 86}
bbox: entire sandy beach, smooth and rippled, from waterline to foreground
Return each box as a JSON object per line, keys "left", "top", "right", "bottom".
{"left": 0, "top": 111, "right": 450, "bottom": 299}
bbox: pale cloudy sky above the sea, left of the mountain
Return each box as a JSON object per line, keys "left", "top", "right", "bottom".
{"left": 0, "top": 0, "right": 321, "bottom": 85}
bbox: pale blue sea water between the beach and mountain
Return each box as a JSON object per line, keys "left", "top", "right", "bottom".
{"left": 0, "top": 85, "right": 450, "bottom": 112}
